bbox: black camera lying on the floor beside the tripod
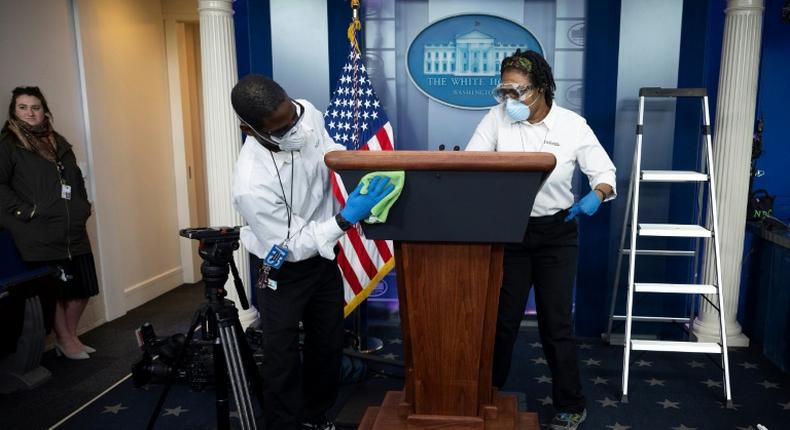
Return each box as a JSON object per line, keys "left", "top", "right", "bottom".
{"left": 132, "top": 323, "right": 214, "bottom": 391}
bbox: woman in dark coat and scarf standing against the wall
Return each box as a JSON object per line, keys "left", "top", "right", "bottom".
{"left": 0, "top": 87, "right": 99, "bottom": 359}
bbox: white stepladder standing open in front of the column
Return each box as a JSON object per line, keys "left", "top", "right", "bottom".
{"left": 604, "top": 88, "right": 732, "bottom": 407}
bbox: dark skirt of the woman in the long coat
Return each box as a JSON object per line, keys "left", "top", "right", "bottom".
{"left": 25, "top": 253, "right": 99, "bottom": 300}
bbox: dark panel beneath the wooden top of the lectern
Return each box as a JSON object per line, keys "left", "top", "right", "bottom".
{"left": 339, "top": 170, "right": 547, "bottom": 243}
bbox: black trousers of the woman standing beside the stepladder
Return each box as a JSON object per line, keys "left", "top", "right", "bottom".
{"left": 493, "top": 211, "right": 585, "bottom": 412}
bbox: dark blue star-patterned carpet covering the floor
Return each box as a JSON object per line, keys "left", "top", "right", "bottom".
{"left": 59, "top": 327, "right": 790, "bottom": 430}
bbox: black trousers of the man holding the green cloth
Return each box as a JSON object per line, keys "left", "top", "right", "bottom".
{"left": 258, "top": 257, "right": 343, "bottom": 430}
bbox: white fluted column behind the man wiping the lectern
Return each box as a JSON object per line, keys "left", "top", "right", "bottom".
{"left": 198, "top": 0, "right": 258, "bottom": 328}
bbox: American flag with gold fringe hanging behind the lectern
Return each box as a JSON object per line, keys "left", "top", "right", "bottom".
{"left": 324, "top": 45, "right": 395, "bottom": 316}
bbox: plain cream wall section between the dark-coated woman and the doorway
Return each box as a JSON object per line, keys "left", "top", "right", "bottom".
{"left": 75, "top": 0, "right": 181, "bottom": 319}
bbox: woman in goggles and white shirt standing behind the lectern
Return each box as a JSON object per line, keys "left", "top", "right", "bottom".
{"left": 466, "top": 50, "right": 615, "bottom": 430}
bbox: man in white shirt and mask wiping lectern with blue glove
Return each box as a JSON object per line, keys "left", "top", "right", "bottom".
{"left": 231, "top": 75, "right": 393, "bottom": 430}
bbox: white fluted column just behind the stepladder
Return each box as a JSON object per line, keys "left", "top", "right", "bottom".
{"left": 693, "top": 0, "right": 763, "bottom": 347}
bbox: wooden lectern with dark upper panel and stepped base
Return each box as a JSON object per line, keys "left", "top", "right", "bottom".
{"left": 325, "top": 151, "right": 556, "bottom": 430}
